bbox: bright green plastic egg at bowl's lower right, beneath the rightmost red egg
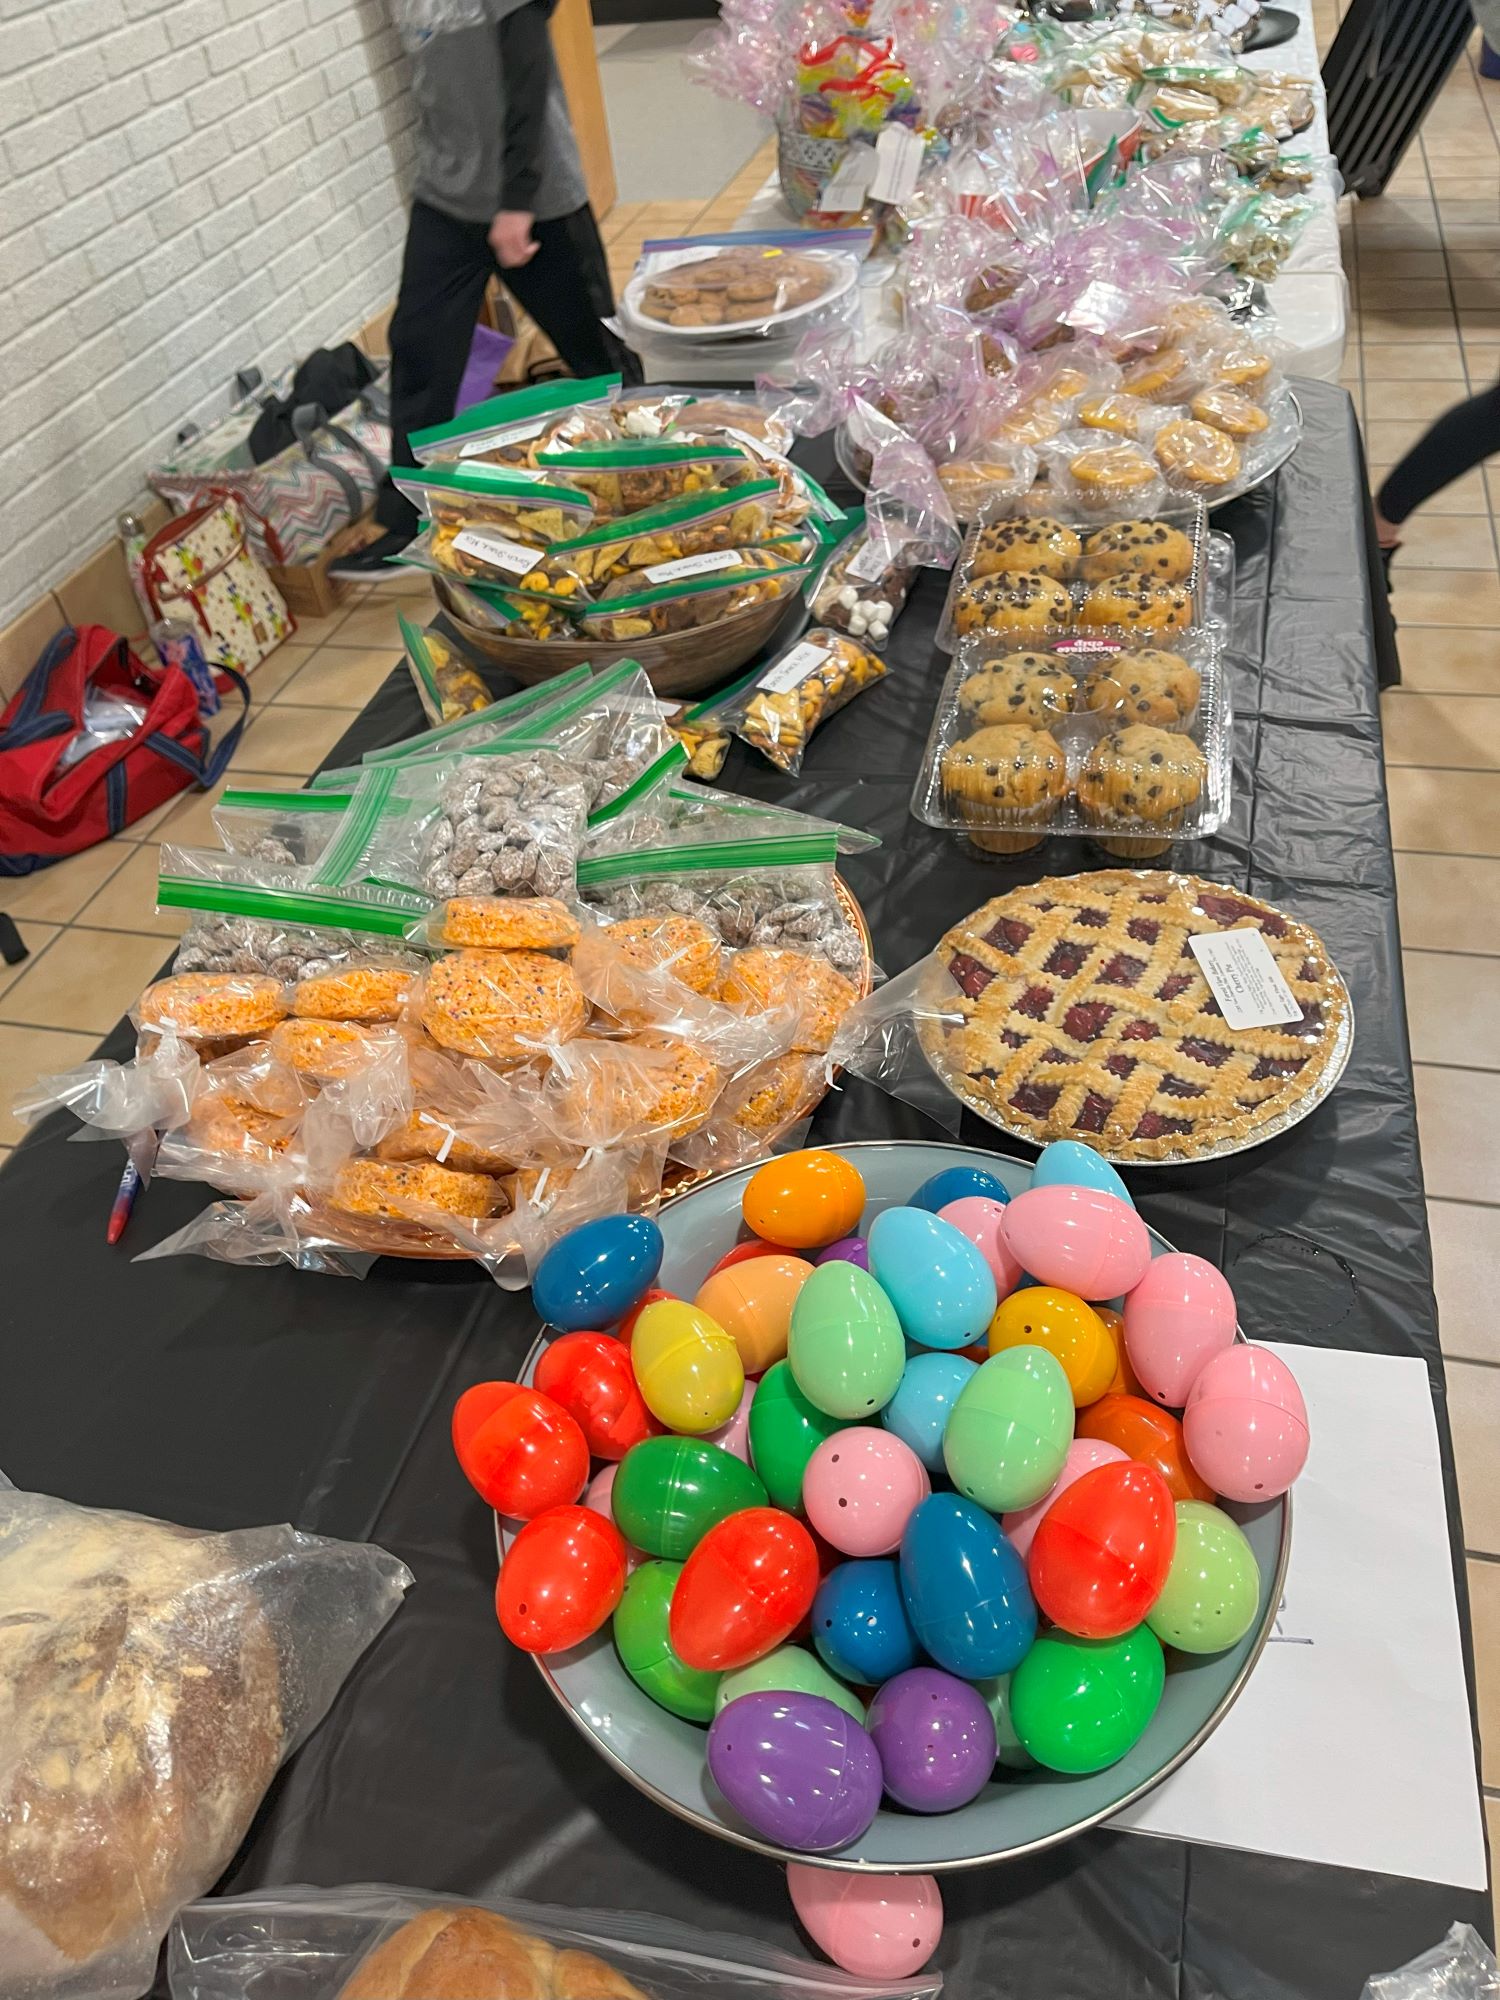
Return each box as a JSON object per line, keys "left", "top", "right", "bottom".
{"left": 1010, "top": 1626, "right": 1166, "bottom": 1776}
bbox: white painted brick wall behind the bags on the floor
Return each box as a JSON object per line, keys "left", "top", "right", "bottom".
{"left": 0, "top": 0, "right": 412, "bottom": 626}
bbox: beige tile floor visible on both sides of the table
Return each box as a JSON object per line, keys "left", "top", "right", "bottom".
{"left": 14, "top": 78, "right": 1500, "bottom": 1896}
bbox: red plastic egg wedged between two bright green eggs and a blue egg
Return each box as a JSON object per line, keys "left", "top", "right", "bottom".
{"left": 670, "top": 1506, "right": 818, "bottom": 1674}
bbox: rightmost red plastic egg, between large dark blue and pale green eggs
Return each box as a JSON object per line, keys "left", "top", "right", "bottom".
{"left": 1026, "top": 1458, "right": 1178, "bottom": 1638}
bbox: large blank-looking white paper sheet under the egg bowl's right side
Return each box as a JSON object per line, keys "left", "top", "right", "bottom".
{"left": 1110, "top": 1342, "right": 1486, "bottom": 1888}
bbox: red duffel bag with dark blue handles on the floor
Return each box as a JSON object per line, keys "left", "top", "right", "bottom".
{"left": 0, "top": 626, "right": 250, "bottom": 876}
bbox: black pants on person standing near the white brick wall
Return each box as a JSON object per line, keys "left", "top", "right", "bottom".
{"left": 376, "top": 202, "right": 634, "bottom": 534}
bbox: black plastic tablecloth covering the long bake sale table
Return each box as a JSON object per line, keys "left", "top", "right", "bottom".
{"left": 0, "top": 384, "right": 1490, "bottom": 2000}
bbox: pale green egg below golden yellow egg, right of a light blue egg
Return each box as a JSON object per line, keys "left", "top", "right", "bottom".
{"left": 942, "top": 1348, "right": 1072, "bottom": 1514}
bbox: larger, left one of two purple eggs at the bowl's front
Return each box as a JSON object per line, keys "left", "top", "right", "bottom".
{"left": 708, "top": 1694, "right": 880, "bottom": 1854}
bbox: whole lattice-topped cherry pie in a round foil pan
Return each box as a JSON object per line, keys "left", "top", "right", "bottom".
{"left": 920, "top": 868, "right": 1350, "bottom": 1160}
